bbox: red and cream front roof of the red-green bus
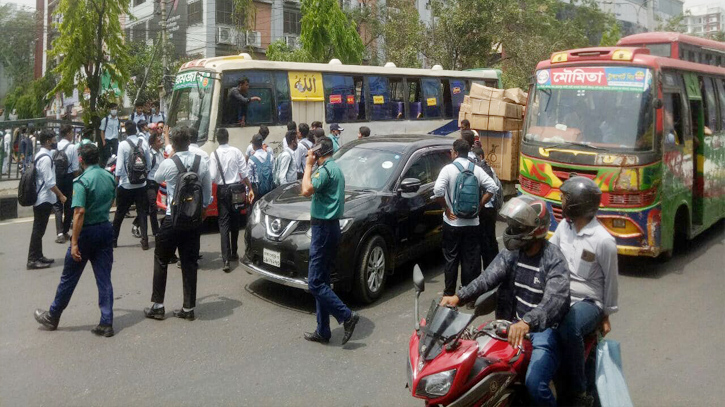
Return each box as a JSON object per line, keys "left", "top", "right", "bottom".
{"left": 536, "top": 47, "right": 725, "bottom": 75}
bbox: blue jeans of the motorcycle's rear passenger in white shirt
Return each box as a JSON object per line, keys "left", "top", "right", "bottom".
{"left": 557, "top": 301, "right": 603, "bottom": 395}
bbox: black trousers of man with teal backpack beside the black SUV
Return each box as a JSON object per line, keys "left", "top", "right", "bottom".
{"left": 443, "top": 222, "right": 481, "bottom": 295}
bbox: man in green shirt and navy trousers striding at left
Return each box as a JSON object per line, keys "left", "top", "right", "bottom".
{"left": 35, "top": 144, "right": 116, "bottom": 337}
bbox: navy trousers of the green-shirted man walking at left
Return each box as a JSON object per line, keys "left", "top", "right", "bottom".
{"left": 49, "top": 222, "right": 113, "bottom": 325}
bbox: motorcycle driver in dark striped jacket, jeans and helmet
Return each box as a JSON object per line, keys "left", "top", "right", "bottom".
{"left": 440, "top": 195, "right": 569, "bottom": 406}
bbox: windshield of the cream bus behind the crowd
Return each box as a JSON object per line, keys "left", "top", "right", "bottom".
{"left": 168, "top": 71, "right": 214, "bottom": 140}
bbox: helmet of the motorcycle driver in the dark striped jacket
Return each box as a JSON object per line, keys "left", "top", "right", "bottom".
{"left": 499, "top": 195, "right": 550, "bottom": 250}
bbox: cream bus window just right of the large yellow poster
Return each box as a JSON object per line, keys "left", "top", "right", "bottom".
{"left": 322, "top": 74, "right": 365, "bottom": 123}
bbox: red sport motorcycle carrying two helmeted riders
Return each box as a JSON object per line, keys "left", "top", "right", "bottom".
{"left": 407, "top": 265, "right": 595, "bottom": 407}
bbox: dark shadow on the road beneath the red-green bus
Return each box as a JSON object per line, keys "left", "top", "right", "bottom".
{"left": 619, "top": 221, "right": 725, "bottom": 279}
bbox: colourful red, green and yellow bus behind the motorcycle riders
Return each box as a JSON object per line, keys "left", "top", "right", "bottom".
{"left": 519, "top": 47, "right": 725, "bottom": 258}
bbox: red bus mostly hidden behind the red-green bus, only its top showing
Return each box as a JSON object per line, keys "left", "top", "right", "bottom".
{"left": 617, "top": 32, "right": 725, "bottom": 66}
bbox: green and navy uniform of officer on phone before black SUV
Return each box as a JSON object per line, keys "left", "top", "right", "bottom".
{"left": 307, "top": 158, "right": 352, "bottom": 339}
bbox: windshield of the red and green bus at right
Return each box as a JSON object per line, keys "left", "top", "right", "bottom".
{"left": 524, "top": 67, "right": 654, "bottom": 151}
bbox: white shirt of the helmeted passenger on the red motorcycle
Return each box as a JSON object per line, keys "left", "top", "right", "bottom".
{"left": 549, "top": 218, "right": 619, "bottom": 315}
